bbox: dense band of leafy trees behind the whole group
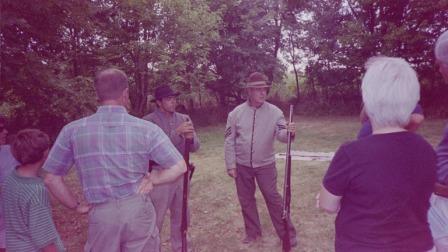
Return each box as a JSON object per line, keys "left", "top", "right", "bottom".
{"left": 0, "top": 0, "right": 448, "bottom": 137}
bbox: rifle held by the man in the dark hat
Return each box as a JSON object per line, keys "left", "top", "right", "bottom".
{"left": 180, "top": 132, "right": 193, "bottom": 252}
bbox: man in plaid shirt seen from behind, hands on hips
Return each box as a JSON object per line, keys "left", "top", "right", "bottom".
{"left": 43, "top": 68, "right": 186, "bottom": 251}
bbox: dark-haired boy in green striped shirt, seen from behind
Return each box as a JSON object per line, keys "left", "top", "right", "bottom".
{"left": 2, "top": 129, "right": 65, "bottom": 252}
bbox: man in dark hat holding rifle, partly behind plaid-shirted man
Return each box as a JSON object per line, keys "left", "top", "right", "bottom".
{"left": 143, "top": 85, "right": 199, "bottom": 251}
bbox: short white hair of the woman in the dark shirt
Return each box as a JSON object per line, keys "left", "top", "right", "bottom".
{"left": 361, "top": 56, "right": 420, "bottom": 128}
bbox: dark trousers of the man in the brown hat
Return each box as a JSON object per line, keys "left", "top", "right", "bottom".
{"left": 235, "top": 163, "right": 296, "bottom": 240}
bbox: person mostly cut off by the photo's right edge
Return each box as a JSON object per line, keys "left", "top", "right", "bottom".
{"left": 428, "top": 31, "right": 448, "bottom": 252}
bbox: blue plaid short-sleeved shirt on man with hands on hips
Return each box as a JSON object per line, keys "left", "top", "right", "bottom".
{"left": 43, "top": 106, "right": 182, "bottom": 203}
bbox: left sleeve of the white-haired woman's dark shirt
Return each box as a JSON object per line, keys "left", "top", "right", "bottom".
{"left": 322, "top": 146, "right": 350, "bottom": 196}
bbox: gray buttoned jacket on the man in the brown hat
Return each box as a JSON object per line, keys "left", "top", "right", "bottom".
{"left": 224, "top": 102, "right": 288, "bottom": 169}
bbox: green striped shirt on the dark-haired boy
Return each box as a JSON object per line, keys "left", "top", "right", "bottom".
{"left": 2, "top": 171, "right": 65, "bottom": 252}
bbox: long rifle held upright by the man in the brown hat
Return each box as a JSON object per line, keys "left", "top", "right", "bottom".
{"left": 282, "top": 105, "right": 294, "bottom": 252}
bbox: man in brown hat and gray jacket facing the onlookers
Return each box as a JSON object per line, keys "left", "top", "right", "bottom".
{"left": 224, "top": 72, "right": 297, "bottom": 246}
